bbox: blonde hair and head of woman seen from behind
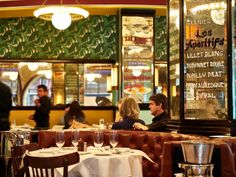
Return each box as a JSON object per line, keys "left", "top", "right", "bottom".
{"left": 119, "top": 97, "right": 140, "bottom": 119}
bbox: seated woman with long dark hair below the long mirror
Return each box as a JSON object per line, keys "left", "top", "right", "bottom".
{"left": 64, "top": 101, "right": 85, "bottom": 129}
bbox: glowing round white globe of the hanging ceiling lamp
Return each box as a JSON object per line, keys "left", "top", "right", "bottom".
{"left": 52, "top": 12, "right": 71, "bottom": 30}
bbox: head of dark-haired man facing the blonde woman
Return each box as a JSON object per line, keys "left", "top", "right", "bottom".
{"left": 149, "top": 93, "right": 167, "bottom": 116}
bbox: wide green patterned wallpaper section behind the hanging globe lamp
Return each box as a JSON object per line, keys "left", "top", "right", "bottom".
{"left": 0, "top": 16, "right": 117, "bottom": 60}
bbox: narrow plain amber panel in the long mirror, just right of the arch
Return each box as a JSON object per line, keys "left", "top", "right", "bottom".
{"left": 52, "top": 63, "right": 65, "bottom": 105}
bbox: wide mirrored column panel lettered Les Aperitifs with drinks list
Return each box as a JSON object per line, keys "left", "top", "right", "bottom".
{"left": 184, "top": 0, "right": 227, "bottom": 120}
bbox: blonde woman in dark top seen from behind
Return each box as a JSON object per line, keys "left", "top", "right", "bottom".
{"left": 112, "top": 97, "right": 145, "bottom": 130}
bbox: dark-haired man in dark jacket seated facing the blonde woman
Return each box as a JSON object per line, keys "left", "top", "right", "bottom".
{"left": 133, "top": 93, "right": 169, "bottom": 131}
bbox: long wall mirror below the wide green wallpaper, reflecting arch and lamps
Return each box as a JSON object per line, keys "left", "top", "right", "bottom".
{"left": 0, "top": 62, "right": 113, "bottom": 106}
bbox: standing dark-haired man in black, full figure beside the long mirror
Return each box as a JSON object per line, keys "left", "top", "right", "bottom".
{"left": 29, "top": 85, "right": 51, "bottom": 130}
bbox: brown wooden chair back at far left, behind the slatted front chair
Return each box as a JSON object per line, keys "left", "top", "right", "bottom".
{"left": 11, "top": 143, "right": 38, "bottom": 177}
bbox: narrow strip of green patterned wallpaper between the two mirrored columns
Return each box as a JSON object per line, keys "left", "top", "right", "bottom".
{"left": 155, "top": 16, "right": 167, "bottom": 60}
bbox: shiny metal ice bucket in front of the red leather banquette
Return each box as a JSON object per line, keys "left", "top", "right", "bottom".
{"left": 181, "top": 141, "right": 214, "bottom": 164}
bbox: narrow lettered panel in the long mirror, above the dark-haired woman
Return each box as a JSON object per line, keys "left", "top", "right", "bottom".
{"left": 65, "top": 63, "right": 79, "bottom": 103}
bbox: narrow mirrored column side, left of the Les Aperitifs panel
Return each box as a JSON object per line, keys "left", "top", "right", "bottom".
{"left": 169, "top": 0, "right": 180, "bottom": 120}
